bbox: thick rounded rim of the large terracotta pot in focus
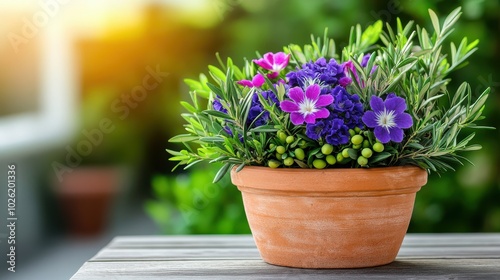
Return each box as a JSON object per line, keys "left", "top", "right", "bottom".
{"left": 231, "top": 165, "right": 428, "bottom": 196}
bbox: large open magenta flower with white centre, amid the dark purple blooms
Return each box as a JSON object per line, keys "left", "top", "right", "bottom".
{"left": 280, "top": 84, "right": 333, "bottom": 125}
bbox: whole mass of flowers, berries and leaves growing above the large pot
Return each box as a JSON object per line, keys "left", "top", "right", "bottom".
{"left": 167, "top": 8, "right": 489, "bottom": 181}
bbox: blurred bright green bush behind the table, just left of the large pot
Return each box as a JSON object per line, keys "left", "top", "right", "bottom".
{"left": 145, "top": 164, "right": 250, "bottom": 234}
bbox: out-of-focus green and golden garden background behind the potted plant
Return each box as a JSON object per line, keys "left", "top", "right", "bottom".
{"left": 0, "top": 0, "right": 500, "bottom": 236}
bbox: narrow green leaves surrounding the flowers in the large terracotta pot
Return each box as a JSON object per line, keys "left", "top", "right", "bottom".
{"left": 168, "top": 8, "right": 490, "bottom": 181}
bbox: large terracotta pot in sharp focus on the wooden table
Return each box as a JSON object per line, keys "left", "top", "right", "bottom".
{"left": 231, "top": 166, "right": 427, "bottom": 268}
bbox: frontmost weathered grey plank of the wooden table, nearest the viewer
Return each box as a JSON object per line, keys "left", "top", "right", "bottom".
{"left": 71, "top": 259, "right": 500, "bottom": 280}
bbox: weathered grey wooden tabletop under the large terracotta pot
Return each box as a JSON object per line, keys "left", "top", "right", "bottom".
{"left": 71, "top": 233, "right": 500, "bottom": 280}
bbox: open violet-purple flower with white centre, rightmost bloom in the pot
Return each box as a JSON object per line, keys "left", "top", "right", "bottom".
{"left": 363, "top": 94, "right": 413, "bottom": 143}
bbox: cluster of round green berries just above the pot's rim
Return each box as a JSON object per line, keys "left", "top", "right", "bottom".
{"left": 268, "top": 128, "right": 385, "bottom": 169}
